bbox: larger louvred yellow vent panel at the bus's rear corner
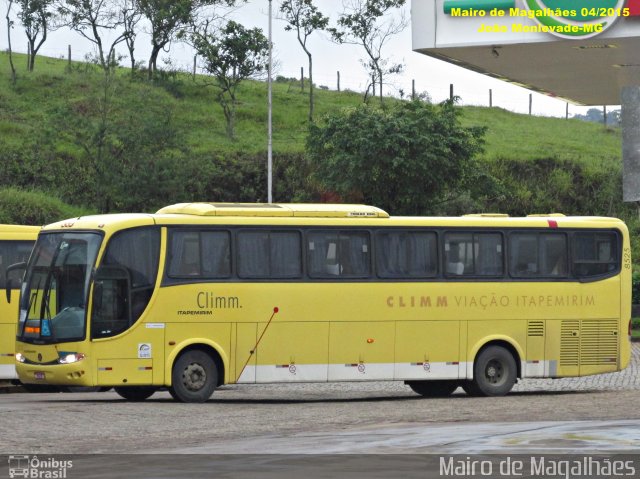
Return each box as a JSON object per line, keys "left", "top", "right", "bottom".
{"left": 560, "top": 319, "right": 619, "bottom": 366}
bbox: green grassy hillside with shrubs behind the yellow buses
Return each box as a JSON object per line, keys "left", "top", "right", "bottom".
{"left": 0, "top": 53, "right": 635, "bottom": 224}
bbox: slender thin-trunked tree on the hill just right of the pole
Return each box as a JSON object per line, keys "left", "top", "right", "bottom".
{"left": 280, "top": 0, "right": 329, "bottom": 122}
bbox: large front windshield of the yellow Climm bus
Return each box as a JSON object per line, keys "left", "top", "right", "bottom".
{"left": 18, "top": 232, "right": 102, "bottom": 344}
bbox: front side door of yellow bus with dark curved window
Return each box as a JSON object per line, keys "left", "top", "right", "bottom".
{"left": 91, "top": 227, "right": 165, "bottom": 386}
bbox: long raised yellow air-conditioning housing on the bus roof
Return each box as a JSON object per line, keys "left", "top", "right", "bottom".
{"left": 157, "top": 203, "right": 389, "bottom": 218}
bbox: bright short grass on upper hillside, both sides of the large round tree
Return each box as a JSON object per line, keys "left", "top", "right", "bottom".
{"left": 0, "top": 53, "right": 621, "bottom": 161}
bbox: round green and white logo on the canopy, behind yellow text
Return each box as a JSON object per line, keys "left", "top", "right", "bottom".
{"left": 524, "top": 0, "right": 628, "bottom": 38}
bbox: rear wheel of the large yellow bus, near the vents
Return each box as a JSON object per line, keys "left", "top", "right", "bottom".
{"left": 463, "top": 346, "right": 517, "bottom": 396}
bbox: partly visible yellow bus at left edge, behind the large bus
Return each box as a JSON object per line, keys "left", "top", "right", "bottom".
{"left": 0, "top": 224, "right": 40, "bottom": 381}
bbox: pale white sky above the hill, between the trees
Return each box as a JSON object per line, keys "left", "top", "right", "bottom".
{"left": 0, "top": 0, "right": 600, "bottom": 117}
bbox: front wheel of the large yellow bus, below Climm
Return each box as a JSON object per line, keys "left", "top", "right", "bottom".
{"left": 170, "top": 349, "right": 218, "bottom": 402}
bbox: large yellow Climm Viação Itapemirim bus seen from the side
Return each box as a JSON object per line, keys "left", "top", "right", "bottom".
{"left": 16, "top": 203, "right": 631, "bottom": 402}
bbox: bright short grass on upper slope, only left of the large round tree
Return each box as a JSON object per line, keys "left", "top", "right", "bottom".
{"left": 0, "top": 52, "right": 362, "bottom": 154}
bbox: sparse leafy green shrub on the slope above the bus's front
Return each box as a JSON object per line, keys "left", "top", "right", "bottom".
{"left": 49, "top": 75, "right": 185, "bottom": 213}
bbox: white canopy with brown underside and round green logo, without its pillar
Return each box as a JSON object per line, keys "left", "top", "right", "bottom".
{"left": 411, "top": 0, "right": 640, "bottom": 105}
